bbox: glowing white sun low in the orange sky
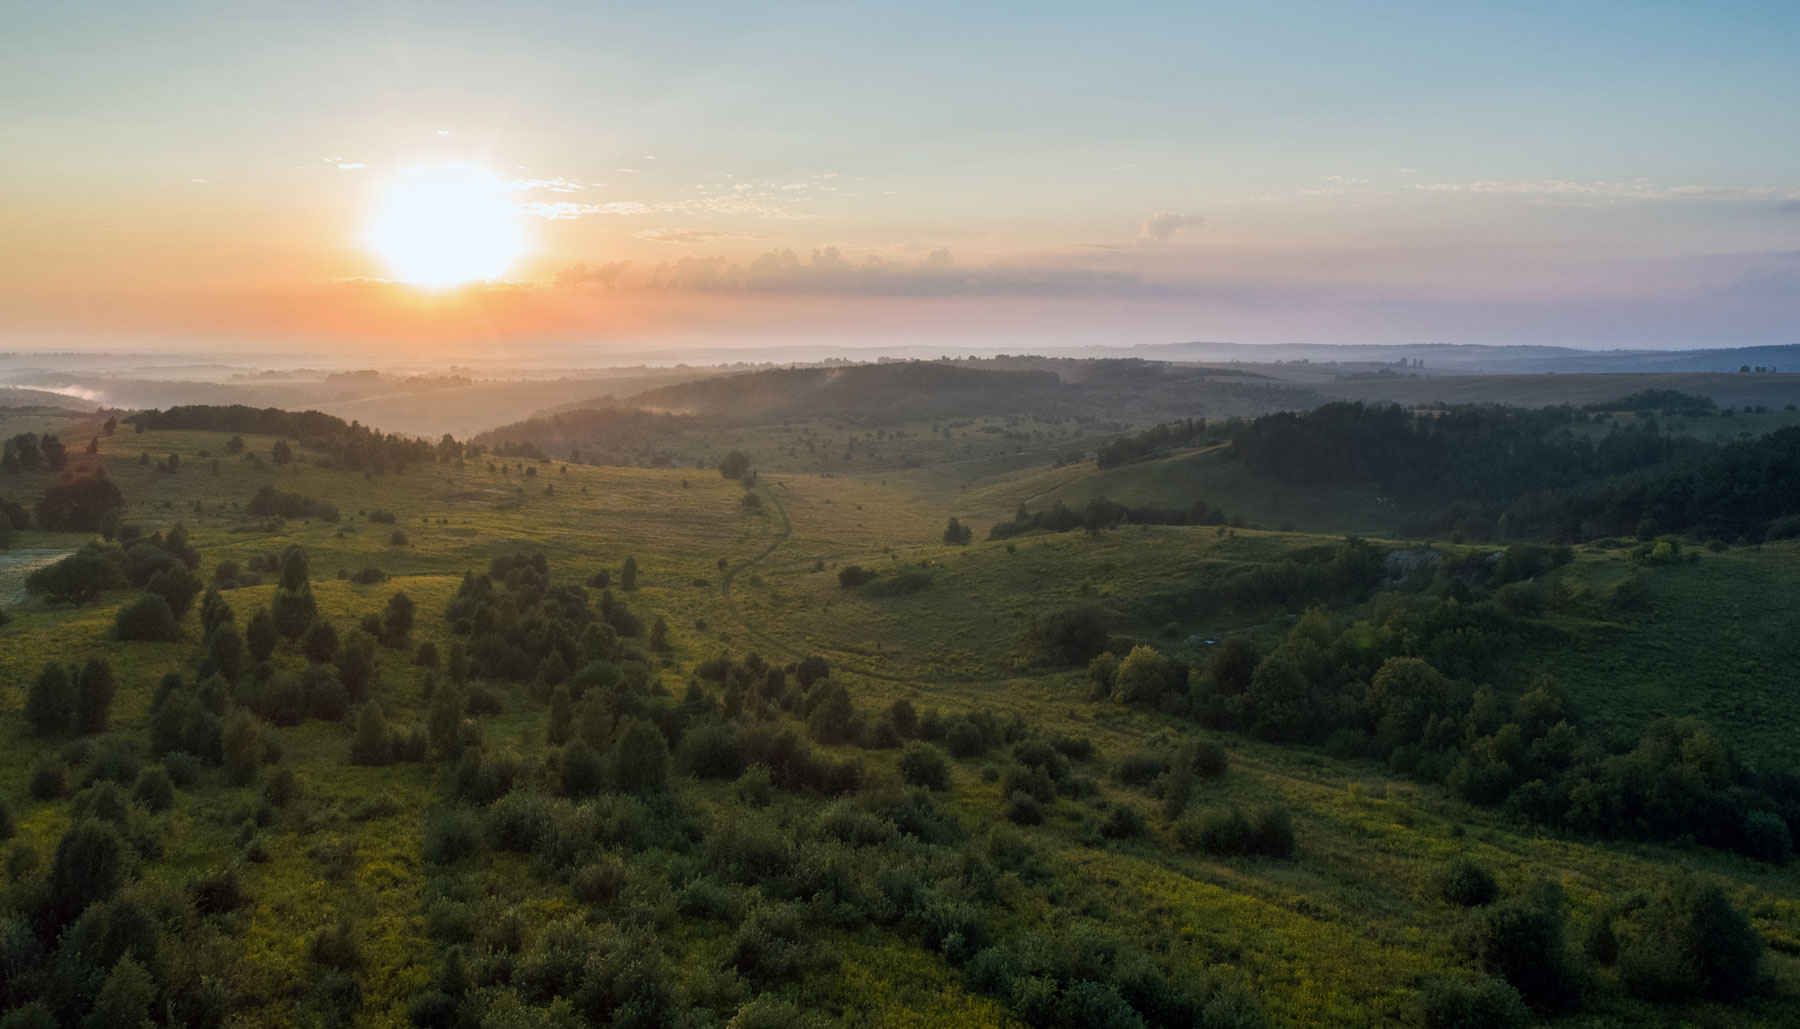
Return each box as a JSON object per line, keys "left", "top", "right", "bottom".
{"left": 364, "top": 164, "right": 526, "bottom": 290}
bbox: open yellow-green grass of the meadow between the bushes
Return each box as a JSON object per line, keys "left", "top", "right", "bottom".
{"left": 0, "top": 419, "right": 1800, "bottom": 1025}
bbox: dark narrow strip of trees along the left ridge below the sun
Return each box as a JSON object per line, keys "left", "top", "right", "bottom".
{"left": 130, "top": 405, "right": 446, "bottom": 471}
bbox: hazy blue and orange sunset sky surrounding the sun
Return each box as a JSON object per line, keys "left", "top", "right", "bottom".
{"left": 0, "top": 0, "right": 1800, "bottom": 354}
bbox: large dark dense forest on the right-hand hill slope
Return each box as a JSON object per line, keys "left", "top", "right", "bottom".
{"left": 1233, "top": 401, "right": 1800, "bottom": 540}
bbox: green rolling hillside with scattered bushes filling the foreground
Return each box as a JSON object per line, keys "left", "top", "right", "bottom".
{"left": 0, "top": 412, "right": 1800, "bottom": 1025}
